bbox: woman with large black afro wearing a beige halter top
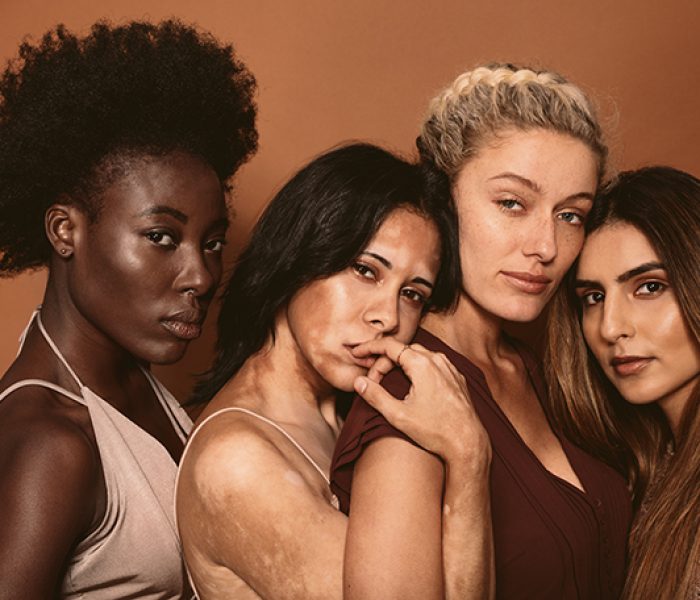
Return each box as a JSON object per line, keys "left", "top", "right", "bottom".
{"left": 0, "top": 21, "right": 257, "bottom": 599}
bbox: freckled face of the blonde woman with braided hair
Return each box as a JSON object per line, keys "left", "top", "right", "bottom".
{"left": 454, "top": 129, "right": 597, "bottom": 322}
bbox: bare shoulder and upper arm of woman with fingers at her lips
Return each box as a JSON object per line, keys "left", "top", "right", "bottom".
{"left": 177, "top": 415, "right": 347, "bottom": 600}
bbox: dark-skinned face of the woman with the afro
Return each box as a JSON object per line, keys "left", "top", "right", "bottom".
{"left": 69, "top": 153, "right": 227, "bottom": 364}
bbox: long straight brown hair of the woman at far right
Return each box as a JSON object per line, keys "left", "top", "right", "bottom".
{"left": 545, "top": 167, "right": 700, "bottom": 600}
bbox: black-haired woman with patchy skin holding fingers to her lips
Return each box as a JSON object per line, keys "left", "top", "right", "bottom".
{"left": 177, "top": 144, "right": 486, "bottom": 600}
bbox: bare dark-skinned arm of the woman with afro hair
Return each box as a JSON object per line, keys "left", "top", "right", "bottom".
{"left": 0, "top": 392, "right": 99, "bottom": 600}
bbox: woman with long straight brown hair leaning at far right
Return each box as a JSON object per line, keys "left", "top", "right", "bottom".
{"left": 547, "top": 167, "right": 700, "bottom": 600}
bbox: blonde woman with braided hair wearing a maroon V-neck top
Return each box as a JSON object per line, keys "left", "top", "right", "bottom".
{"left": 332, "top": 64, "right": 630, "bottom": 600}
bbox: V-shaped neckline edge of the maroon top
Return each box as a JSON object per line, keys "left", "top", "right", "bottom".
{"left": 419, "top": 328, "right": 589, "bottom": 501}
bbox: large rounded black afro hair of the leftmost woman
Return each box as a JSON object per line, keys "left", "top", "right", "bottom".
{"left": 0, "top": 20, "right": 257, "bottom": 276}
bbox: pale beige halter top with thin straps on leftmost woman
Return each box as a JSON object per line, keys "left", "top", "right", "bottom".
{"left": 0, "top": 311, "right": 192, "bottom": 600}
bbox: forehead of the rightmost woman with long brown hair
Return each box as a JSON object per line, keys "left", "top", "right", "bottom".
{"left": 577, "top": 223, "right": 660, "bottom": 279}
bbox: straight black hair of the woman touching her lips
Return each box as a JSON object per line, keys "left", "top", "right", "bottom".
{"left": 190, "top": 143, "right": 461, "bottom": 403}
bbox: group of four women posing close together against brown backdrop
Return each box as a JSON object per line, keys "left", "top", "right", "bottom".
{"left": 0, "top": 16, "right": 700, "bottom": 600}
